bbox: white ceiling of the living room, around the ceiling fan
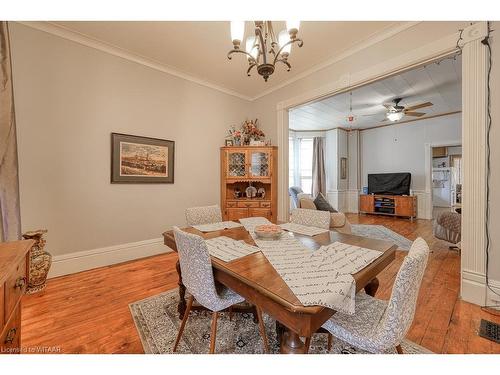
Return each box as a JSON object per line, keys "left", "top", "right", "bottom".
{"left": 289, "top": 56, "right": 462, "bottom": 131}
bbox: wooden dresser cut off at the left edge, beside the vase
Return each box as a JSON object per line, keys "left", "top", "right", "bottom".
{"left": 0, "top": 240, "right": 35, "bottom": 354}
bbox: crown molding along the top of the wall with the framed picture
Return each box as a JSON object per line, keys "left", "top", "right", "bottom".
{"left": 16, "top": 21, "right": 252, "bottom": 101}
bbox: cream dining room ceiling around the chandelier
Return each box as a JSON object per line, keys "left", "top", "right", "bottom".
{"left": 52, "top": 21, "right": 406, "bottom": 98}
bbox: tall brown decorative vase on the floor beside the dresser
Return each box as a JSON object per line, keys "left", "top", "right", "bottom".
{"left": 23, "top": 229, "right": 52, "bottom": 294}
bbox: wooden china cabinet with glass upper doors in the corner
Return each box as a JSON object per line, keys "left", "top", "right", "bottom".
{"left": 220, "top": 146, "right": 278, "bottom": 223}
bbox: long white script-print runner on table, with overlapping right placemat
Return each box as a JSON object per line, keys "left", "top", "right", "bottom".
{"left": 240, "top": 218, "right": 382, "bottom": 314}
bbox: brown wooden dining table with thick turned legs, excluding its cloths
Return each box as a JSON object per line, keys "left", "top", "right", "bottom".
{"left": 163, "top": 227, "right": 397, "bottom": 354}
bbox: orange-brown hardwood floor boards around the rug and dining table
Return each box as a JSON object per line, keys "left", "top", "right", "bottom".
{"left": 22, "top": 215, "right": 500, "bottom": 353}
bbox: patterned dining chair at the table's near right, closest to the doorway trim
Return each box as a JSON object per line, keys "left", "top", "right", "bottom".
{"left": 316, "top": 237, "right": 429, "bottom": 354}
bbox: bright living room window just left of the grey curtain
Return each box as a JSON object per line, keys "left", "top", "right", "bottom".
{"left": 288, "top": 133, "right": 313, "bottom": 194}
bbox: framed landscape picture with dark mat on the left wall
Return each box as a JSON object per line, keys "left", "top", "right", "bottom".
{"left": 111, "top": 133, "right": 175, "bottom": 184}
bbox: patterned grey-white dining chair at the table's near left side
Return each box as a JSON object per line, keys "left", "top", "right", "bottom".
{"left": 173, "top": 227, "right": 269, "bottom": 354}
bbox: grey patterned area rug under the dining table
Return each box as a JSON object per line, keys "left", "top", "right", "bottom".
{"left": 129, "top": 289, "right": 431, "bottom": 354}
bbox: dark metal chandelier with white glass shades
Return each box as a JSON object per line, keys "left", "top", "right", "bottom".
{"left": 227, "top": 21, "right": 304, "bottom": 82}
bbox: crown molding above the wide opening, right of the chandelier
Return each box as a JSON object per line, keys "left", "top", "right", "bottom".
{"left": 251, "top": 21, "right": 422, "bottom": 101}
